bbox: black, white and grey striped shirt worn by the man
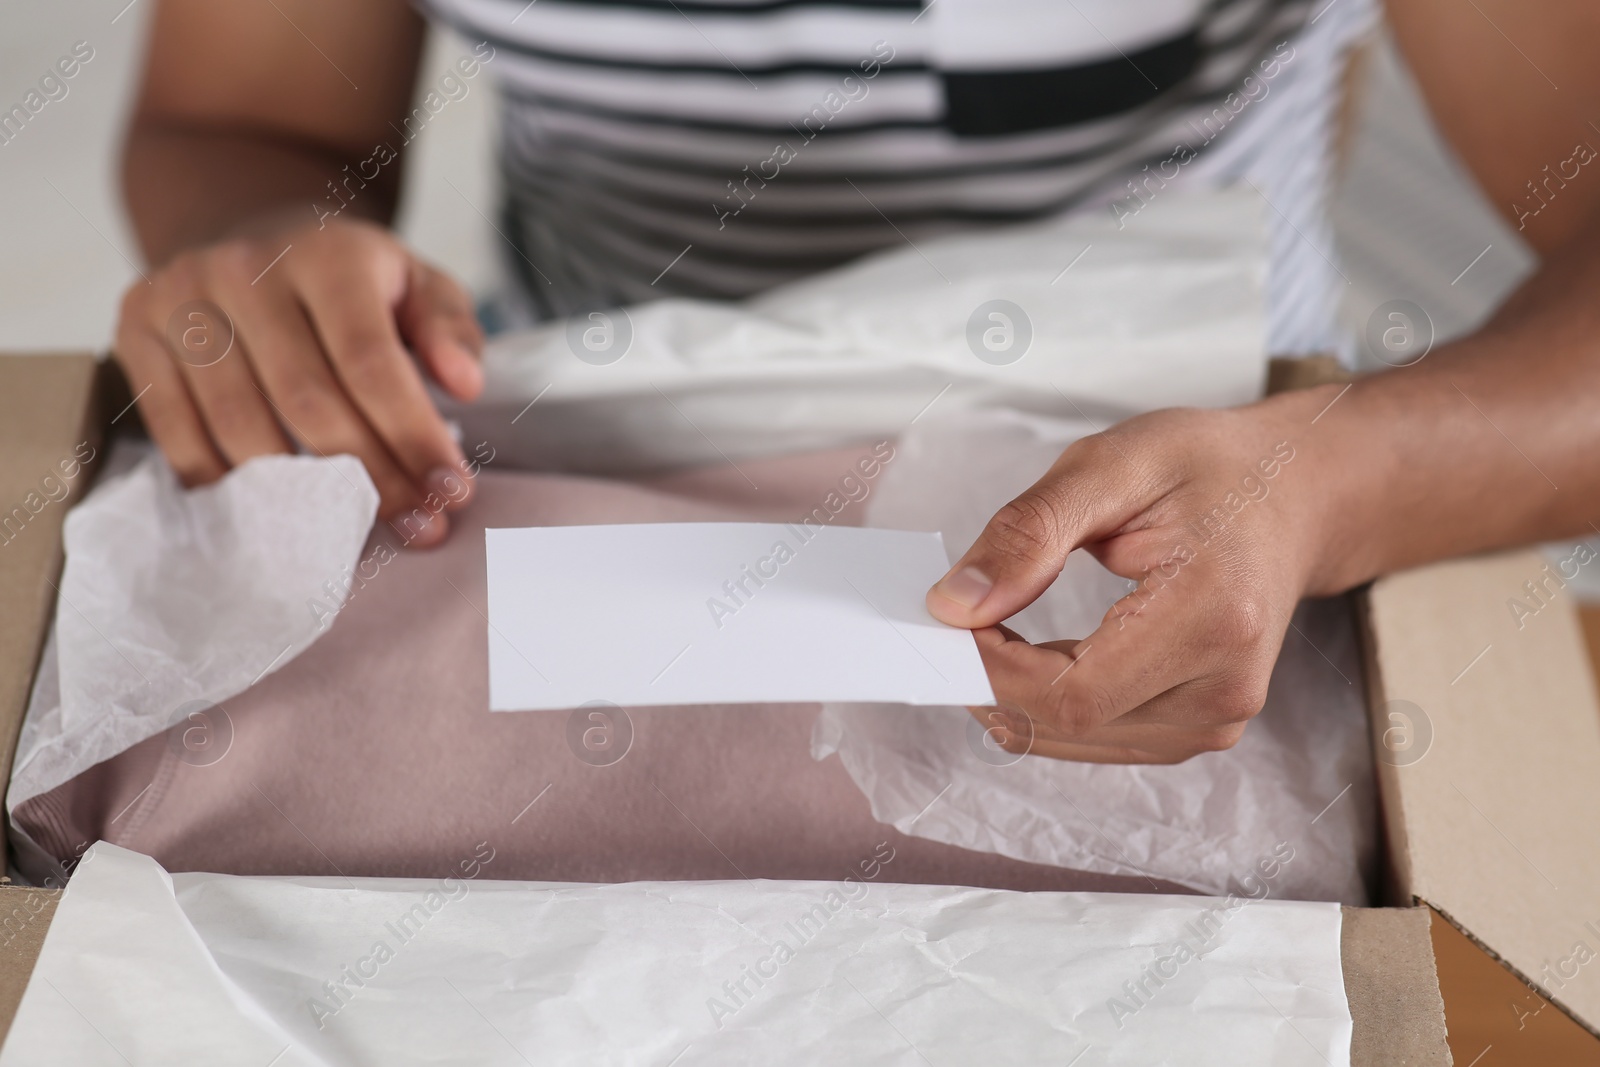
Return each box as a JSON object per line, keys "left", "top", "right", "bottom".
{"left": 422, "top": 0, "right": 1371, "bottom": 352}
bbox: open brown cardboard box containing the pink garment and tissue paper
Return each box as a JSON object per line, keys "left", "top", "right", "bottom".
{"left": 0, "top": 355, "right": 1600, "bottom": 1065}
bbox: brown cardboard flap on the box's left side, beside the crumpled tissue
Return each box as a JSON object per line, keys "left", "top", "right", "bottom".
{"left": 0, "top": 355, "right": 106, "bottom": 856}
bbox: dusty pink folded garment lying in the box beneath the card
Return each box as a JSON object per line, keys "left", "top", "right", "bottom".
{"left": 14, "top": 450, "right": 1186, "bottom": 893}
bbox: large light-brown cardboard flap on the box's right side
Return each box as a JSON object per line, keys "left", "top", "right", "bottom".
{"left": 1366, "top": 552, "right": 1600, "bottom": 1032}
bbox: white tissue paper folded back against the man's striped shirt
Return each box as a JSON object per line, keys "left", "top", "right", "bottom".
{"left": 442, "top": 187, "right": 1267, "bottom": 474}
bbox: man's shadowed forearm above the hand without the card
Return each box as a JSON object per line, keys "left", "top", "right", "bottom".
{"left": 122, "top": 118, "right": 400, "bottom": 264}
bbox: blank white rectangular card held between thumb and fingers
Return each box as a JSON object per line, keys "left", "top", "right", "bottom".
{"left": 485, "top": 523, "right": 994, "bottom": 712}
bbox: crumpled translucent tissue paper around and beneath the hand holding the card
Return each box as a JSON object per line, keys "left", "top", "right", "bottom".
{"left": 813, "top": 413, "right": 1378, "bottom": 905}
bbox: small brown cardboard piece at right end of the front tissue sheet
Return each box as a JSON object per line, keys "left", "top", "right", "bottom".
{"left": 1339, "top": 907, "right": 1450, "bottom": 1067}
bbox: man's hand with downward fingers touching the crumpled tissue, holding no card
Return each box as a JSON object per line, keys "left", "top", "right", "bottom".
{"left": 115, "top": 219, "right": 483, "bottom": 545}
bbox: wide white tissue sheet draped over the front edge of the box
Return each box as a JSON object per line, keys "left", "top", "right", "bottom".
{"left": 0, "top": 843, "right": 1352, "bottom": 1067}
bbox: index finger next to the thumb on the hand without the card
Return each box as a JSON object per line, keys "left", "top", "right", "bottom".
{"left": 293, "top": 258, "right": 470, "bottom": 504}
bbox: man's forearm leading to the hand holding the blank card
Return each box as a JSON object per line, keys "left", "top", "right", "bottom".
{"left": 1298, "top": 207, "right": 1600, "bottom": 592}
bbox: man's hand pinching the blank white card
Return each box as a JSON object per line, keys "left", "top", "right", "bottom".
{"left": 928, "top": 390, "right": 1328, "bottom": 763}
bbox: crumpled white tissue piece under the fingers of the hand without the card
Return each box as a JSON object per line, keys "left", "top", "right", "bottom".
{"left": 6, "top": 445, "right": 378, "bottom": 811}
